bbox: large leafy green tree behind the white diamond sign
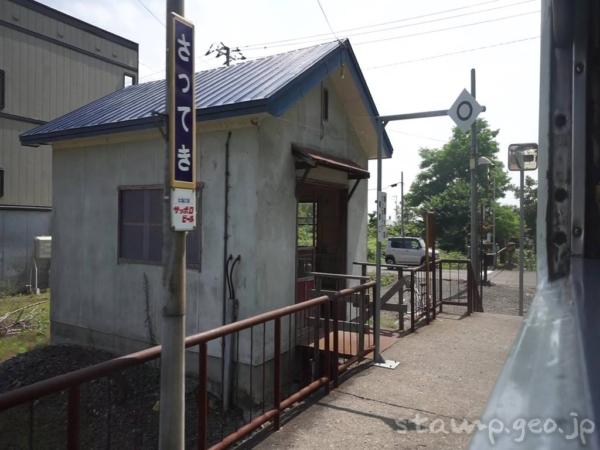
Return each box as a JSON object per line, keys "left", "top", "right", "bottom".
{"left": 405, "top": 119, "right": 518, "bottom": 251}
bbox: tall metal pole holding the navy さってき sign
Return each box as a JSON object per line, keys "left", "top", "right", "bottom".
{"left": 159, "top": 0, "right": 186, "bottom": 450}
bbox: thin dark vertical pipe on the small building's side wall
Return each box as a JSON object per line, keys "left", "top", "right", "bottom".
{"left": 221, "top": 131, "right": 231, "bottom": 411}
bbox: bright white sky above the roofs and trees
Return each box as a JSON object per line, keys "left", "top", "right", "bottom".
{"left": 41, "top": 0, "right": 540, "bottom": 211}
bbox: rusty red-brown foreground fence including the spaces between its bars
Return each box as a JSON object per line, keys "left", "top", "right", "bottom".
{"left": 0, "top": 282, "right": 375, "bottom": 449}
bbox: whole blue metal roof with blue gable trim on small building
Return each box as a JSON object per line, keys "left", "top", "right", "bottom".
{"left": 21, "top": 40, "right": 393, "bottom": 156}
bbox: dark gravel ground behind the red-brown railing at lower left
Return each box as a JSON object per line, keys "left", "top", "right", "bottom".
{"left": 0, "top": 345, "right": 241, "bottom": 450}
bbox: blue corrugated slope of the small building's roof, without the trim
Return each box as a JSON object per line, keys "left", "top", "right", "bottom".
{"left": 24, "top": 42, "right": 340, "bottom": 141}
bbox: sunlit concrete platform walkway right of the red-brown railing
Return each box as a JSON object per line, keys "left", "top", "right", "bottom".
{"left": 258, "top": 313, "right": 521, "bottom": 450}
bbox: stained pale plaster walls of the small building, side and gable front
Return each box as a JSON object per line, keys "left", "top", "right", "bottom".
{"left": 51, "top": 75, "right": 367, "bottom": 363}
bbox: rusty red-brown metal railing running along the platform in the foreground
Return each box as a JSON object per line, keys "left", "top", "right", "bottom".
{"left": 0, "top": 282, "right": 375, "bottom": 449}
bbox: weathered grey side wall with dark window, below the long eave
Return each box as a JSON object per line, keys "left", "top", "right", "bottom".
{"left": 51, "top": 129, "right": 257, "bottom": 353}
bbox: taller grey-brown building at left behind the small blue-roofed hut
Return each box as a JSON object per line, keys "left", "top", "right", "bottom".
{"left": 0, "top": 0, "right": 138, "bottom": 292}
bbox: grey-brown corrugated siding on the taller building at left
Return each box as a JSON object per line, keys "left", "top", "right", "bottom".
{"left": 0, "top": 0, "right": 137, "bottom": 207}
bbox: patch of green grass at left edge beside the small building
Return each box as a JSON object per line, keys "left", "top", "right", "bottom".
{"left": 0, "top": 292, "right": 50, "bottom": 362}
